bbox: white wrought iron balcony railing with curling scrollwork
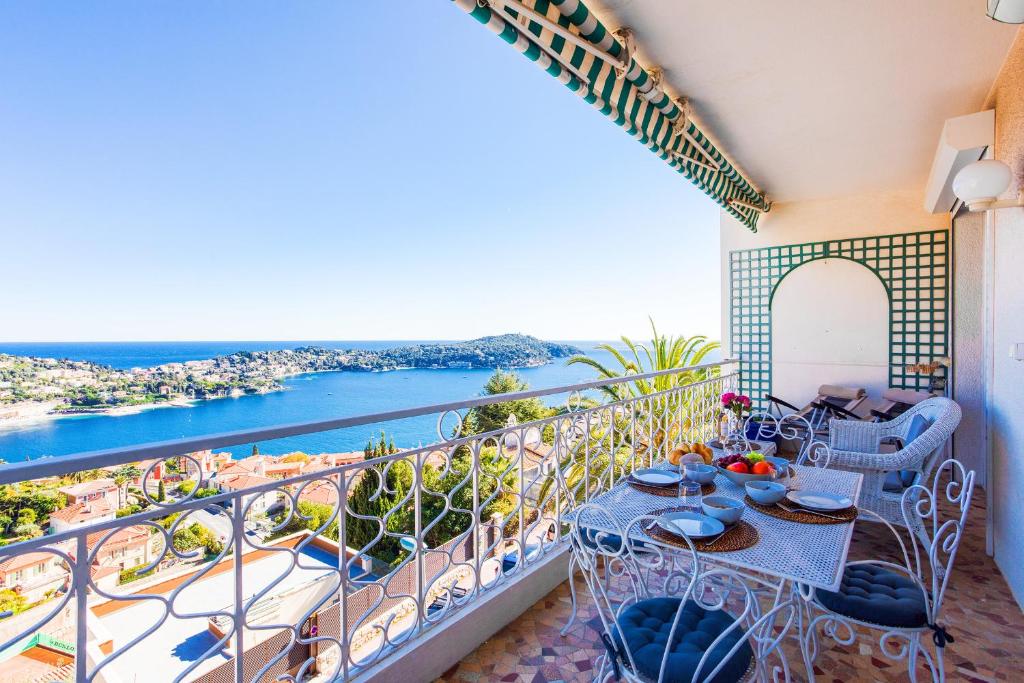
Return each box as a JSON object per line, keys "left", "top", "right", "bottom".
{"left": 0, "top": 360, "right": 739, "bottom": 683}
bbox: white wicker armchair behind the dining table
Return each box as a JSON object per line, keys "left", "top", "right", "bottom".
{"left": 829, "top": 398, "right": 961, "bottom": 525}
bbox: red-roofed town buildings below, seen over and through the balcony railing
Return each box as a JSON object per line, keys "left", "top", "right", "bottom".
{"left": 0, "top": 428, "right": 551, "bottom": 683}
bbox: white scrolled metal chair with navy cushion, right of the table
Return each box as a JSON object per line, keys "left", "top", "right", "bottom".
{"left": 802, "top": 460, "right": 975, "bottom": 682}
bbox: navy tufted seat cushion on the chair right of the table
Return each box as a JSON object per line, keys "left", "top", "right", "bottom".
{"left": 815, "top": 564, "right": 928, "bottom": 629}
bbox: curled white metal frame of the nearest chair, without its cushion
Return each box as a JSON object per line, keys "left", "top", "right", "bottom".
{"left": 569, "top": 503, "right": 797, "bottom": 682}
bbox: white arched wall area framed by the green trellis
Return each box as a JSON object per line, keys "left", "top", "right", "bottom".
{"left": 771, "top": 258, "right": 889, "bottom": 405}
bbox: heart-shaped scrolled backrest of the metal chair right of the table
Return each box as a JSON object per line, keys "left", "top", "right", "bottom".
{"left": 901, "top": 459, "right": 975, "bottom": 624}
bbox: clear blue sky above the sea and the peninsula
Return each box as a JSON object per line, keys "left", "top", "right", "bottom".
{"left": 0, "top": 0, "right": 719, "bottom": 341}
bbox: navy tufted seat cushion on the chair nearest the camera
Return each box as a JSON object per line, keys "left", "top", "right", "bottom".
{"left": 615, "top": 597, "right": 754, "bottom": 683}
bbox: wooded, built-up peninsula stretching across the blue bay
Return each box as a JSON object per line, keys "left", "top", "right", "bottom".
{"left": 0, "top": 334, "right": 581, "bottom": 426}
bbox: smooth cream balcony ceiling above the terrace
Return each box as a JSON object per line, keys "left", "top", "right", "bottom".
{"left": 588, "top": 0, "right": 1017, "bottom": 202}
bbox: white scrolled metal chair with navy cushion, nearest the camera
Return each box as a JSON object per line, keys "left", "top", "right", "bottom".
{"left": 571, "top": 504, "right": 797, "bottom": 683}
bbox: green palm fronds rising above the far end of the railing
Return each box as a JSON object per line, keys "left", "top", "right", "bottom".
{"left": 566, "top": 318, "right": 722, "bottom": 400}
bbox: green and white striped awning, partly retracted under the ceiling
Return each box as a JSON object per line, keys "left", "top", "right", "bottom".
{"left": 454, "top": 0, "right": 771, "bottom": 232}
